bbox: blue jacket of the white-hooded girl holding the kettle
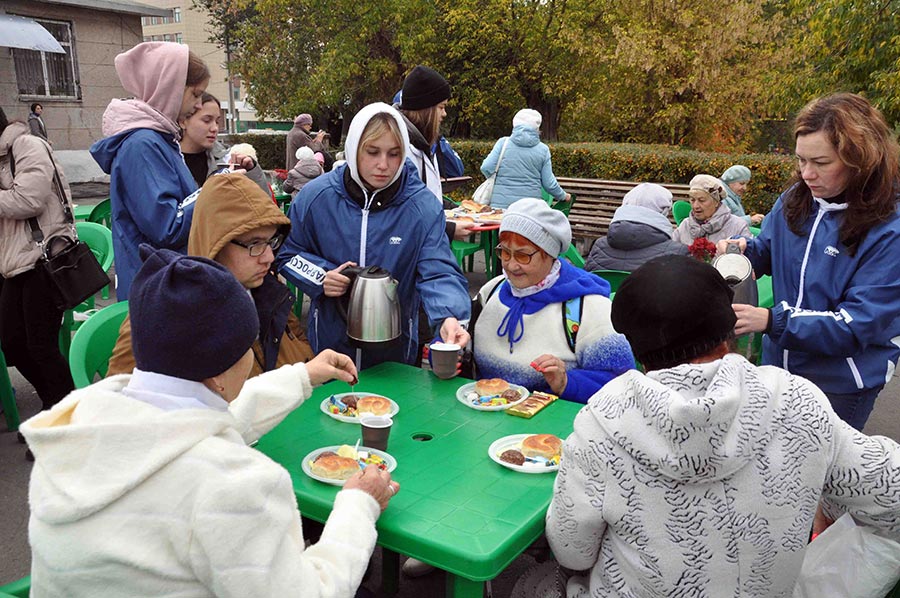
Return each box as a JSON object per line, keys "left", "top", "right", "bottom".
{"left": 276, "top": 160, "right": 471, "bottom": 368}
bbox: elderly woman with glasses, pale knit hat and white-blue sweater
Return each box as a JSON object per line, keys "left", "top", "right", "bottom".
{"left": 472, "top": 199, "right": 634, "bottom": 403}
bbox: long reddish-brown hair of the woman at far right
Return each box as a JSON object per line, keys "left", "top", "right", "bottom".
{"left": 784, "top": 93, "right": 900, "bottom": 255}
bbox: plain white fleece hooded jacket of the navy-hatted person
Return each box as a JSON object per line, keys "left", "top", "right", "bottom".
{"left": 21, "top": 364, "right": 380, "bottom": 598}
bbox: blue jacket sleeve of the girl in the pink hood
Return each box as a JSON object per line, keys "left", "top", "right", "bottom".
{"left": 115, "top": 135, "right": 197, "bottom": 249}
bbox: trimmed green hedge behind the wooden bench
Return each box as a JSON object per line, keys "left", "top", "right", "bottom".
{"left": 451, "top": 140, "right": 794, "bottom": 214}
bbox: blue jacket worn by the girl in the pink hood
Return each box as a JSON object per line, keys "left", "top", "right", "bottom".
{"left": 91, "top": 129, "right": 197, "bottom": 301}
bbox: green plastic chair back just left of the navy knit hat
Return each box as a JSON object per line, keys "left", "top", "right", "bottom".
{"left": 69, "top": 301, "right": 128, "bottom": 388}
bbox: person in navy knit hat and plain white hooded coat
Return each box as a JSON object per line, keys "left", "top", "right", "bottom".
{"left": 21, "top": 244, "right": 399, "bottom": 598}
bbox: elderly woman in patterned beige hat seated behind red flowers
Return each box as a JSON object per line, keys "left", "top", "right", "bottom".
{"left": 672, "top": 174, "right": 750, "bottom": 245}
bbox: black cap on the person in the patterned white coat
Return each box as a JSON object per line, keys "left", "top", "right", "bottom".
{"left": 612, "top": 255, "right": 737, "bottom": 370}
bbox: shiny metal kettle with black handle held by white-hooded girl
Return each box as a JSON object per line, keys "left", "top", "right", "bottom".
{"left": 339, "top": 266, "right": 400, "bottom": 346}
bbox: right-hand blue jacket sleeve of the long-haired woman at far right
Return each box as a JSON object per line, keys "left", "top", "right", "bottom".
{"left": 769, "top": 232, "right": 900, "bottom": 357}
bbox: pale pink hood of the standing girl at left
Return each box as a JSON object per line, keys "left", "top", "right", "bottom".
{"left": 102, "top": 42, "right": 188, "bottom": 137}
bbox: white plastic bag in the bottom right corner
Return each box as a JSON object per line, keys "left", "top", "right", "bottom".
{"left": 794, "top": 514, "right": 900, "bottom": 598}
